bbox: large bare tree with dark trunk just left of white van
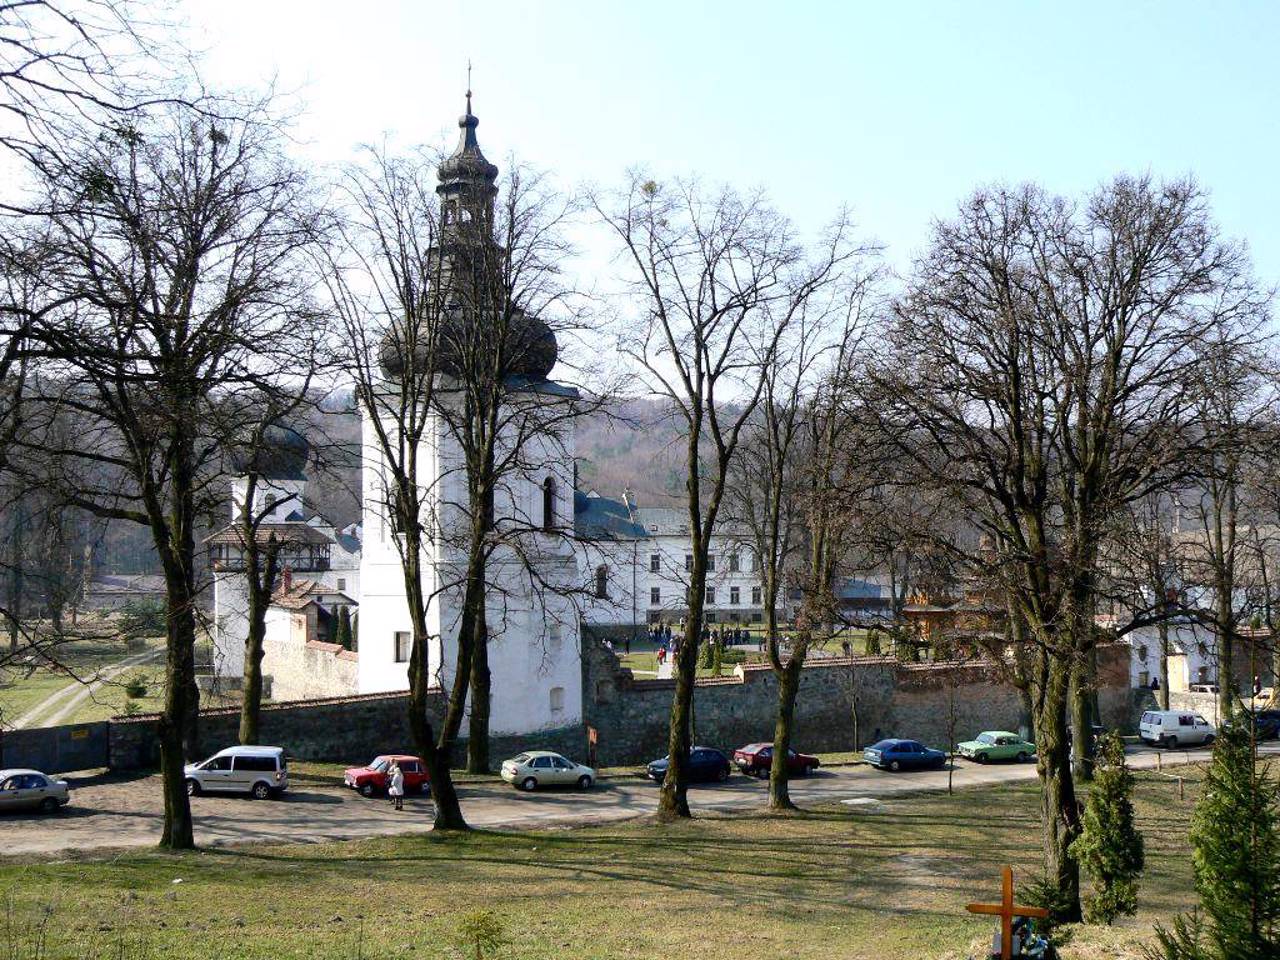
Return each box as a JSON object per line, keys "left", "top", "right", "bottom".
{"left": 13, "top": 97, "right": 320, "bottom": 847}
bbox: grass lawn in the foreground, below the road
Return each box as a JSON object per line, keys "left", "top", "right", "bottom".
{"left": 0, "top": 768, "right": 1198, "bottom": 960}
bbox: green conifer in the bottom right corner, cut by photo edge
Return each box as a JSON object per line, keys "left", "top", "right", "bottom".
{"left": 1148, "top": 723, "right": 1280, "bottom": 960}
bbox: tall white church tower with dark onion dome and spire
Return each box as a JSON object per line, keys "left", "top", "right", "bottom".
{"left": 358, "top": 91, "right": 582, "bottom": 736}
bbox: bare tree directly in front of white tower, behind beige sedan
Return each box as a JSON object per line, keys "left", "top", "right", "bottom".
{"left": 424, "top": 126, "right": 593, "bottom": 773}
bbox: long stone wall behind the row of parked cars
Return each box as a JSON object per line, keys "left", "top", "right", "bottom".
{"left": 110, "top": 640, "right": 1134, "bottom": 769}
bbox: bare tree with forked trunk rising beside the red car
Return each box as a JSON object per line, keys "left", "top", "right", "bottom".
{"left": 325, "top": 138, "right": 471, "bottom": 829}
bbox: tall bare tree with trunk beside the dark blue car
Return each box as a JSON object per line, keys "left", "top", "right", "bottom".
{"left": 593, "top": 175, "right": 849, "bottom": 819}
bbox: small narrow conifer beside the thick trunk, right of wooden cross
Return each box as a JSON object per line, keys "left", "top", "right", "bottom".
{"left": 1071, "top": 733, "right": 1144, "bottom": 924}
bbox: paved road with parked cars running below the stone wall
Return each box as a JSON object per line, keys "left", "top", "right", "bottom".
{"left": 0, "top": 745, "right": 1249, "bottom": 856}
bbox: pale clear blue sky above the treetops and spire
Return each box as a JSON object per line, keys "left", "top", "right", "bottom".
{"left": 182, "top": 0, "right": 1280, "bottom": 283}
